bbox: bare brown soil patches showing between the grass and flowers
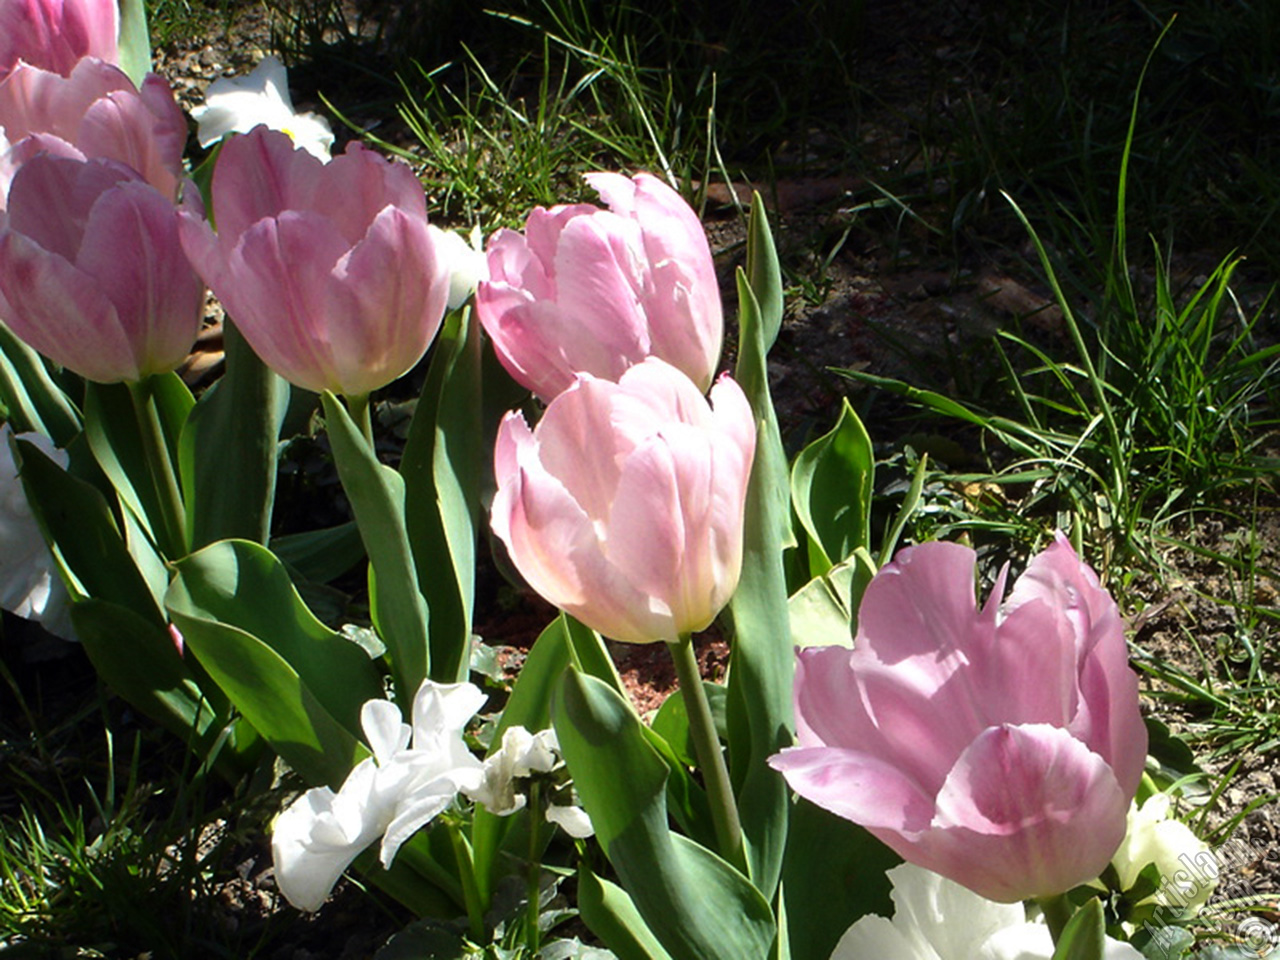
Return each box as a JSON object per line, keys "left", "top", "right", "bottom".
{"left": 0, "top": 5, "right": 1280, "bottom": 960}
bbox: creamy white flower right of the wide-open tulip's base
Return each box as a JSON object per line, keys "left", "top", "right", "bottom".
{"left": 1111, "top": 794, "right": 1219, "bottom": 913}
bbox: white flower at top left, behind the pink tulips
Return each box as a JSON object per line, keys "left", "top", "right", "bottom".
{"left": 191, "top": 56, "right": 333, "bottom": 161}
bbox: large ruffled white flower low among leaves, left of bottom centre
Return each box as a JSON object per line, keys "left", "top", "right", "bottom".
{"left": 271, "top": 680, "right": 485, "bottom": 910}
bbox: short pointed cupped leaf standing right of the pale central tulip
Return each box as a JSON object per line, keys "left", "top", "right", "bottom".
{"left": 791, "top": 399, "right": 876, "bottom": 576}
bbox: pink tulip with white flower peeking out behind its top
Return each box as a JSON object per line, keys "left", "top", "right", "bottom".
{"left": 182, "top": 127, "right": 449, "bottom": 396}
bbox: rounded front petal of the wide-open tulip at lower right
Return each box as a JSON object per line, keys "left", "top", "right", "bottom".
{"left": 921, "top": 724, "right": 1129, "bottom": 902}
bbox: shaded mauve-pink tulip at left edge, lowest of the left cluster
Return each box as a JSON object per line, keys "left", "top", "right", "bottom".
{"left": 0, "top": 154, "right": 205, "bottom": 383}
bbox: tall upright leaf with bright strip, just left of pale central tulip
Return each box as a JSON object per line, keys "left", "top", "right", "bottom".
{"left": 401, "top": 307, "right": 483, "bottom": 684}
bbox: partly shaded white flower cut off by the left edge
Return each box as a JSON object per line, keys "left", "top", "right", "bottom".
{"left": 0, "top": 424, "right": 74, "bottom": 640}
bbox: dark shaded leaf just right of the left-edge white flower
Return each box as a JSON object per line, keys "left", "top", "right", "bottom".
{"left": 13, "top": 440, "right": 165, "bottom": 628}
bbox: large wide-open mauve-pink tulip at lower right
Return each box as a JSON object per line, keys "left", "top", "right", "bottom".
{"left": 771, "top": 534, "right": 1147, "bottom": 902}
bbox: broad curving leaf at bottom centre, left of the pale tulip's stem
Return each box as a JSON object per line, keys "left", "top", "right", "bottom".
{"left": 552, "top": 668, "right": 774, "bottom": 960}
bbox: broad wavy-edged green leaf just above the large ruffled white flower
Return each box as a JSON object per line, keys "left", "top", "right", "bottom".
{"left": 166, "top": 540, "right": 383, "bottom": 747}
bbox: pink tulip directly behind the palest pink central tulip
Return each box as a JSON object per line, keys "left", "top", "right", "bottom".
{"left": 476, "top": 173, "right": 723, "bottom": 401}
